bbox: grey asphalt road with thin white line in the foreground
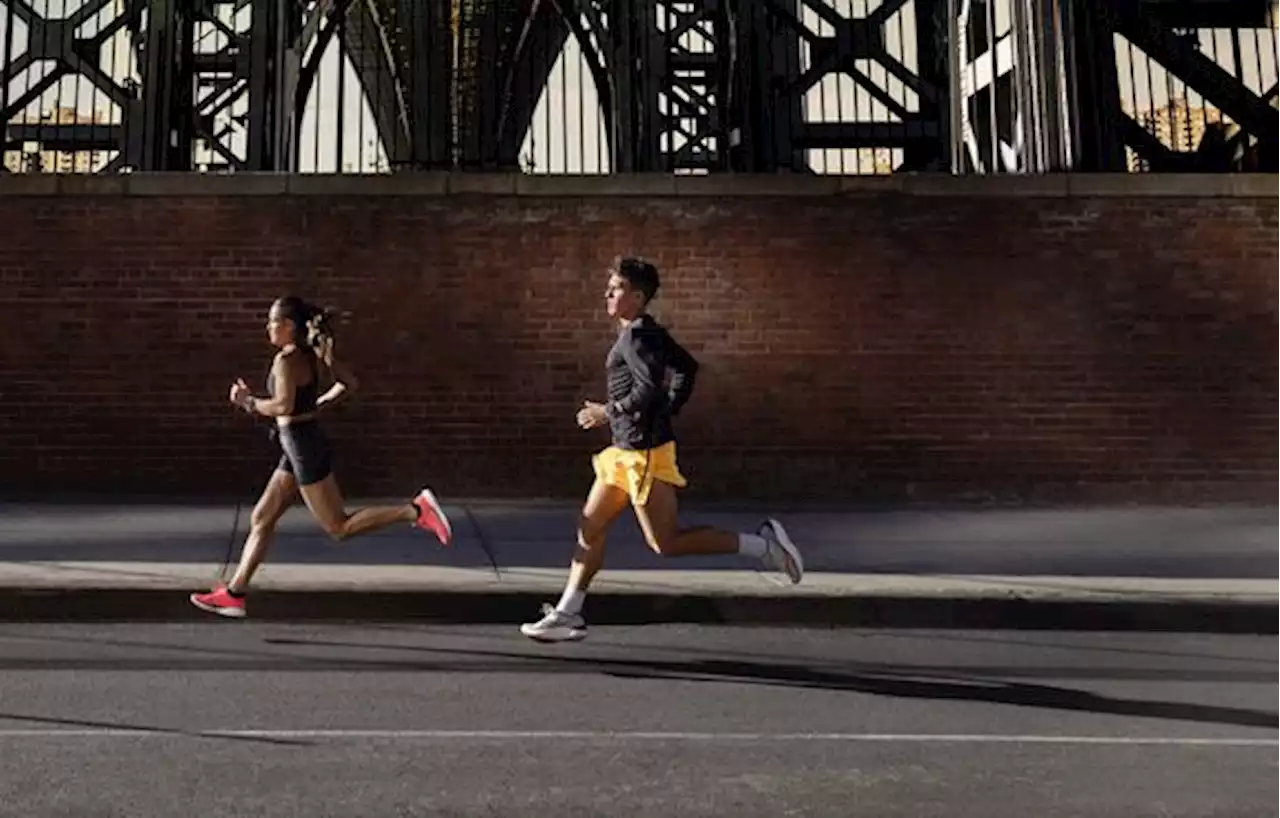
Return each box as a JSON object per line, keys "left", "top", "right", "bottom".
{"left": 0, "top": 621, "right": 1280, "bottom": 818}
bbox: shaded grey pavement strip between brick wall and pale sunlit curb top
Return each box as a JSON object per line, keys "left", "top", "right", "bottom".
{"left": 0, "top": 502, "right": 1280, "bottom": 581}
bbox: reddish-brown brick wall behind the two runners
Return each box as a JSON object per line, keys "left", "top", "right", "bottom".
{"left": 0, "top": 175, "right": 1280, "bottom": 502}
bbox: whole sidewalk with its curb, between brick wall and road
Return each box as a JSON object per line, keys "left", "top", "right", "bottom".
{"left": 0, "top": 501, "right": 1280, "bottom": 632}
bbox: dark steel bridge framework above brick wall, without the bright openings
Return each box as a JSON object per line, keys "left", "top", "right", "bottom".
{"left": 0, "top": 0, "right": 1280, "bottom": 173}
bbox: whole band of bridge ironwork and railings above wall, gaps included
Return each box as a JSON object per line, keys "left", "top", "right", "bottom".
{"left": 0, "top": 0, "right": 1280, "bottom": 175}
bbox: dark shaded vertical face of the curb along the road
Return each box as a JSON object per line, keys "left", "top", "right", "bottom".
{"left": 0, "top": 588, "right": 1280, "bottom": 635}
